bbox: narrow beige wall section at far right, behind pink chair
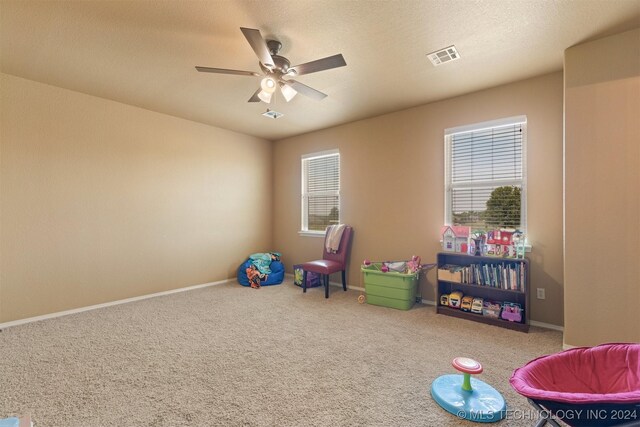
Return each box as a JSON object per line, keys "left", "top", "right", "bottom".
{"left": 564, "top": 29, "right": 640, "bottom": 346}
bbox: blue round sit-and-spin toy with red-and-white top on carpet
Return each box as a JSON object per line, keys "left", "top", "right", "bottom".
{"left": 431, "top": 357, "right": 507, "bottom": 423}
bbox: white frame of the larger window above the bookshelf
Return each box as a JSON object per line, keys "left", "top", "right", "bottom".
{"left": 444, "top": 115, "right": 528, "bottom": 235}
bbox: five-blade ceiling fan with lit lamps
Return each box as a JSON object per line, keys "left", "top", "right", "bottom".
{"left": 196, "top": 27, "right": 347, "bottom": 104}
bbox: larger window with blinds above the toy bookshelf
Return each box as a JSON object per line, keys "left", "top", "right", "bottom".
{"left": 445, "top": 116, "right": 527, "bottom": 231}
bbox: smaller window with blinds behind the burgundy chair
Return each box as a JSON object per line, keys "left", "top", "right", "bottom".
{"left": 302, "top": 150, "right": 340, "bottom": 232}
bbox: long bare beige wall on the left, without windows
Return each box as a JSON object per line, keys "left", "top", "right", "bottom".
{"left": 0, "top": 74, "right": 272, "bottom": 323}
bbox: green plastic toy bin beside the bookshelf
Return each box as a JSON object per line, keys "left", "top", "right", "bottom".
{"left": 362, "top": 263, "right": 418, "bottom": 310}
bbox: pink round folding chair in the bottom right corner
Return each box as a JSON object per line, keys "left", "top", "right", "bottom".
{"left": 509, "top": 343, "right": 640, "bottom": 427}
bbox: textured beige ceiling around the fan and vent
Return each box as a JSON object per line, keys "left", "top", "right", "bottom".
{"left": 0, "top": 0, "right": 640, "bottom": 140}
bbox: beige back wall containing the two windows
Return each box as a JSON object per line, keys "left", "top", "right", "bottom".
{"left": 273, "top": 72, "right": 563, "bottom": 325}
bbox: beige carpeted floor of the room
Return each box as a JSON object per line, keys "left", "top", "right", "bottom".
{"left": 0, "top": 280, "right": 562, "bottom": 427}
